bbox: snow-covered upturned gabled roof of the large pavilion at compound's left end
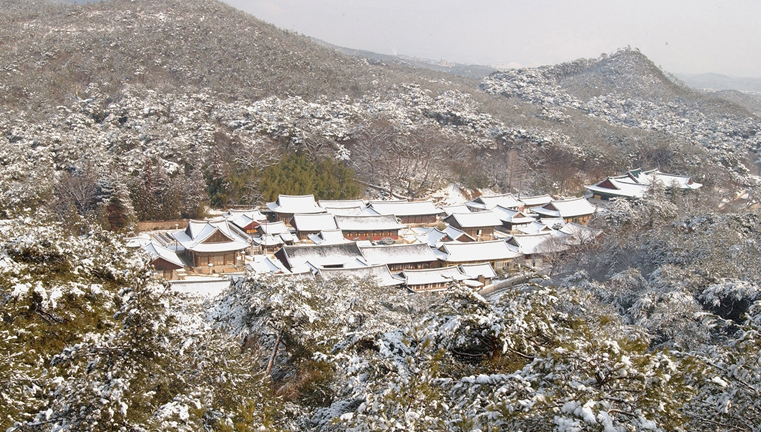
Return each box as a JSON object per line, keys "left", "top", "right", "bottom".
{"left": 172, "top": 219, "right": 248, "bottom": 252}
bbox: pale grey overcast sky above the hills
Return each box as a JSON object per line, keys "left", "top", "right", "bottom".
{"left": 223, "top": 0, "right": 761, "bottom": 77}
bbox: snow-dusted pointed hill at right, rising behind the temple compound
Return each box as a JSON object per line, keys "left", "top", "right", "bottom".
{"left": 481, "top": 49, "right": 761, "bottom": 187}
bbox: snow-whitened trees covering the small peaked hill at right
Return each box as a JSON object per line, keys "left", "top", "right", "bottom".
{"left": 481, "top": 50, "right": 761, "bottom": 183}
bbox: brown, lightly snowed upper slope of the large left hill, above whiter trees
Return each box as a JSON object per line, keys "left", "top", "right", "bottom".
{"left": 0, "top": 0, "right": 454, "bottom": 107}
